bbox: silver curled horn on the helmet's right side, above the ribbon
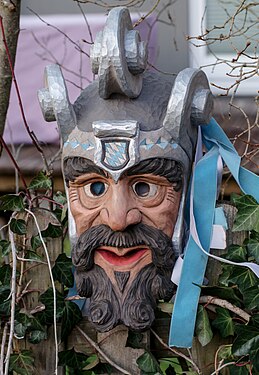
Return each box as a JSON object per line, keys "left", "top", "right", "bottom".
{"left": 163, "top": 68, "right": 213, "bottom": 162}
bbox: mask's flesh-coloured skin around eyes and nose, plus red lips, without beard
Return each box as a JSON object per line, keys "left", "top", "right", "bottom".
{"left": 69, "top": 173, "right": 181, "bottom": 258}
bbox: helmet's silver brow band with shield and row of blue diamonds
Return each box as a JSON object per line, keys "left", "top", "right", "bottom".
{"left": 63, "top": 120, "right": 189, "bottom": 182}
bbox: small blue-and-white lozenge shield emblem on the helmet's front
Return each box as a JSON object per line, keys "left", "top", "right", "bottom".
{"left": 101, "top": 140, "right": 129, "bottom": 170}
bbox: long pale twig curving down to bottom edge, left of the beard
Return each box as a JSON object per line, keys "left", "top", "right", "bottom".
{"left": 25, "top": 209, "right": 58, "bottom": 375}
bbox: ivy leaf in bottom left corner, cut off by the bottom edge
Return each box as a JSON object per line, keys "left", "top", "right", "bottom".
{"left": 9, "top": 350, "right": 35, "bottom": 375}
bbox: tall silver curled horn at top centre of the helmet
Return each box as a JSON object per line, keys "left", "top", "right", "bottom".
{"left": 90, "top": 7, "right": 147, "bottom": 99}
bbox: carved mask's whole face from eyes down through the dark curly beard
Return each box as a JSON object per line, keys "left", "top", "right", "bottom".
{"left": 66, "top": 159, "right": 181, "bottom": 330}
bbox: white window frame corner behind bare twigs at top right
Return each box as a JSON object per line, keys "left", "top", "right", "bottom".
{"left": 188, "top": 0, "right": 259, "bottom": 96}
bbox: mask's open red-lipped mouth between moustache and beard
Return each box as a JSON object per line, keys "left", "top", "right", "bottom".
{"left": 96, "top": 247, "right": 149, "bottom": 266}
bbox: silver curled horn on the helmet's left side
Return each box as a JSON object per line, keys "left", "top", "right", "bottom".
{"left": 38, "top": 64, "right": 76, "bottom": 142}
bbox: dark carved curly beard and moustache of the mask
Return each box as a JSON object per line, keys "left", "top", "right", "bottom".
{"left": 72, "top": 224, "right": 175, "bottom": 332}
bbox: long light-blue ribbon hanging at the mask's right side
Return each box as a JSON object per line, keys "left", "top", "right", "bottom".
{"left": 169, "top": 119, "right": 259, "bottom": 348}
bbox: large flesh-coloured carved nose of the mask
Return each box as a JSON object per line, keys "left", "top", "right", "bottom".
{"left": 100, "top": 182, "right": 141, "bottom": 231}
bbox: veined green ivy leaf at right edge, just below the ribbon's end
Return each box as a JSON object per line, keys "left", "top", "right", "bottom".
{"left": 232, "top": 195, "right": 259, "bottom": 232}
